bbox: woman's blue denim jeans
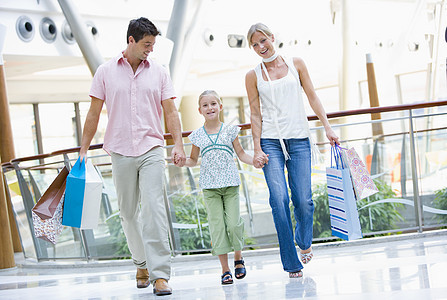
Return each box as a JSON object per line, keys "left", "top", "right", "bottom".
{"left": 261, "top": 138, "right": 314, "bottom": 272}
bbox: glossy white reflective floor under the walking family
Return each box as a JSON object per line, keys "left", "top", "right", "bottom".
{"left": 0, "top": 230, "right": 447, "bottom": 300}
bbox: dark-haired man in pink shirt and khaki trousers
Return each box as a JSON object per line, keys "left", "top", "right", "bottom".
{"left": 79, "top": 18, "right": 186, "bottom": 295}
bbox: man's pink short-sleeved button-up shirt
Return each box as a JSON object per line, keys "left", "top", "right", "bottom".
{"left": 90, "top": 53, "right": 175, "bottom": 156}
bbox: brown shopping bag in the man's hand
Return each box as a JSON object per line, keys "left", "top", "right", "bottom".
{"left": 32, "top": 167, "right": 68, "bottom": 220}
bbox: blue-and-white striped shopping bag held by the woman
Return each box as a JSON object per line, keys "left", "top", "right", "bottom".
{"left": 326, "top": 145, "right": 362, "bottom": 240}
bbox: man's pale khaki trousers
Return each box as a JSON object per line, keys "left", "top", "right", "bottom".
{"left": 111, "top": 147, "right": 171, "bottom": 283}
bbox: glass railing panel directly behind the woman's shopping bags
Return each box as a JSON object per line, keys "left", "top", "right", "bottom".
{"left": 312, "top": 113, "right": 416, "bottom": 239}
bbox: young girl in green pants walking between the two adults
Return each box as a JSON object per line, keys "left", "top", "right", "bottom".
{"left": 185, "top": 91, "right": 253, "bottom": 284}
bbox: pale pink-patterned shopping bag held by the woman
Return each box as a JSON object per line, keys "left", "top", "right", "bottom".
{"left": 341, "top": 147, "right": 379, "bottom": 201}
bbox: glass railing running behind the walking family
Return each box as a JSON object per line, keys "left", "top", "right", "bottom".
{"left": 2, "top": 101, "right": 447, "bottom": 260}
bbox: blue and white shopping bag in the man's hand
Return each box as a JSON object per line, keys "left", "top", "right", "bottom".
{"left": 62, "top": 158, "right": 102, "bottom": 229}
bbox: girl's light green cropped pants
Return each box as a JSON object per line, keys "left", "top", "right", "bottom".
{"left": 203, "top": 186, "right": 244, "bottom": 255}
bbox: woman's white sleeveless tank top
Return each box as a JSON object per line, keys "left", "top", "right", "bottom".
{"left": 255, "top": 58, "right": 309, "bottom": 139}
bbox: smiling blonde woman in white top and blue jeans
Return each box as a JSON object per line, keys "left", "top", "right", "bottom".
{"left": 245, "top": 23, "right": 339, "bottom": 278}
